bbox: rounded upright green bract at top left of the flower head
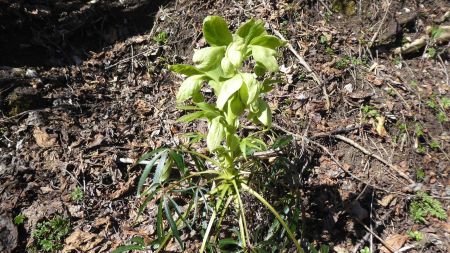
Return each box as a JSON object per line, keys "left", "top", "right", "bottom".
{"left": 203, "top": 16, "right": 233, "bottom": 46}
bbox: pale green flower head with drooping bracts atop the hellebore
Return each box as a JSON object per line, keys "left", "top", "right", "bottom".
{"left": 171, "top": 16, "right": 285, "bottom": 158}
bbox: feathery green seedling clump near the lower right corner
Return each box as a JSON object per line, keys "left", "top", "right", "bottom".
{"left": 409, "top": 192, "right": 447, "bottom": 223}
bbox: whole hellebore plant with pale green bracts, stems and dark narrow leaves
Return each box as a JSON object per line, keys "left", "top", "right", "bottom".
{"left": 133, "top": 16, "right": 303, "bottom": 252}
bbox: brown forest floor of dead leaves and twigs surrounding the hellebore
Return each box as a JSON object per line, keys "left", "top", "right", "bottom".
{"left": 0, "top": 0, "right": 450, "bottom": 253}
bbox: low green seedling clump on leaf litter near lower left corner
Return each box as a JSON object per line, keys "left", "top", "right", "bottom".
{"left": 30, "top": 217, "right": 70, "bottom": 252}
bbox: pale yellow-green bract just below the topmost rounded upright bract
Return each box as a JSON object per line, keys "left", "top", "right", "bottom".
{"left": 192, "top": 47, "right": 225, "bottom": 71}
